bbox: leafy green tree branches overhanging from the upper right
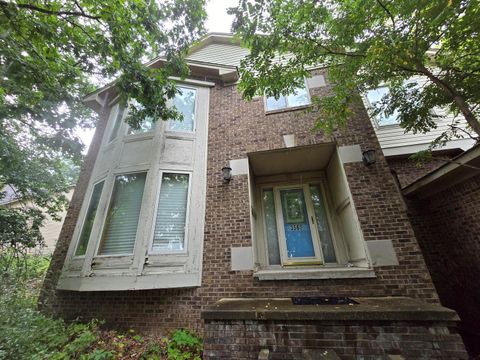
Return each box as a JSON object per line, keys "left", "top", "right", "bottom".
{"left": 230, "top": 0, "right": 480, "bottom": 146}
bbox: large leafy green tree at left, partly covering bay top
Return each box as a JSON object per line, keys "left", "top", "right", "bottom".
{"left": 0, "top": 0, "right": 206, "bottom": 258}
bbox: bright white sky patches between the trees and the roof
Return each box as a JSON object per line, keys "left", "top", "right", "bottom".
{"left": 77, "top": 0, "right": 238, "bottom": 153}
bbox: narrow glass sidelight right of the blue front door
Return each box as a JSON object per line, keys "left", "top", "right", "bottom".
{"left": 310, "top": 185, "right": 337, "bottom": 263}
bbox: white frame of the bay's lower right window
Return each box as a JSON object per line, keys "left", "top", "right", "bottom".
{"left": 147, "top": 169, "right": 192, "bottom": 256}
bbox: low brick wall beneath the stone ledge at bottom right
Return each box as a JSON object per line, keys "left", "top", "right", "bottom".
{"left": 203, "top": 320, "right": 468, "bottom": 360}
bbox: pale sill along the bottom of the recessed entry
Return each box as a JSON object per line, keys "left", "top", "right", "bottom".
{"left": 253, "top": 268, "right": 376, "bottom": 281}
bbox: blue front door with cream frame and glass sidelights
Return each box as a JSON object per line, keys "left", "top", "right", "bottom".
{"left": 262, "top": 183, "right": 337, "bottom": 266}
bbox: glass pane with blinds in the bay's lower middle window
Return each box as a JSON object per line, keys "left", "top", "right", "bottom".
{"left": 99, "top": 173, "right": 147, "bottom": 255}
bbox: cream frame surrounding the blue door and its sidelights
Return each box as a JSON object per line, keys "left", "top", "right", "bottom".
{"left": 256, "top": 171, "right": 347, "bottom": 271}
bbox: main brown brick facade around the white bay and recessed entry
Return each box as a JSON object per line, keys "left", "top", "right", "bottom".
{"left": 41, "top": 75, "right": 438, "bottom": 332}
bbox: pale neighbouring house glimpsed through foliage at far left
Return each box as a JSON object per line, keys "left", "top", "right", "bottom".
{"left": 0, "top": 185, "right": 74, "bottom": 255}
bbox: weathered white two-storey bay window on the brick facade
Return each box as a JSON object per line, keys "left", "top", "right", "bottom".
{"left": 57, "top": 85, "right": 209, "bottom": 291}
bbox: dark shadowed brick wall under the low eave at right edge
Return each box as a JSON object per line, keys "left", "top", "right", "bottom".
{"left": 409, "top": 175, "right": 480, "bottom": 355}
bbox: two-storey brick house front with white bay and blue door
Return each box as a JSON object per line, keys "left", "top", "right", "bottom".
{"left": 40, "top": 34, "right": 467, "bottom": 359}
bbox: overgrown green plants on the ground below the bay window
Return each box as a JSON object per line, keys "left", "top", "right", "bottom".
{"left": 0, "top": 256, "right": 203, "bottom": 360}
